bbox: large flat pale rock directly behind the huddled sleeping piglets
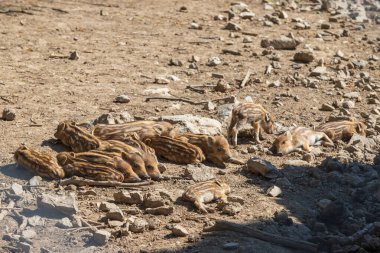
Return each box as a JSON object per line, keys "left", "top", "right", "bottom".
{"left": 158, "top": 114, "right": 222, "bottom": 135}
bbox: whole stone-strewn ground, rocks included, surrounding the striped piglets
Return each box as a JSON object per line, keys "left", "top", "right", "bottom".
{"left": 0, "top": 0, "right": 380, "bottom": 253}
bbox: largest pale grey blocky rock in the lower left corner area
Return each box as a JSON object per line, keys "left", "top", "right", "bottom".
{"left": 37, "top": 193, "right": 78, "bottom": 216}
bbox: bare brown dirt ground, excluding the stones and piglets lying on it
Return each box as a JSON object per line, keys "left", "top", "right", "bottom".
{"left": 0, "top": 0, "right": 380, "bottom": 253}
